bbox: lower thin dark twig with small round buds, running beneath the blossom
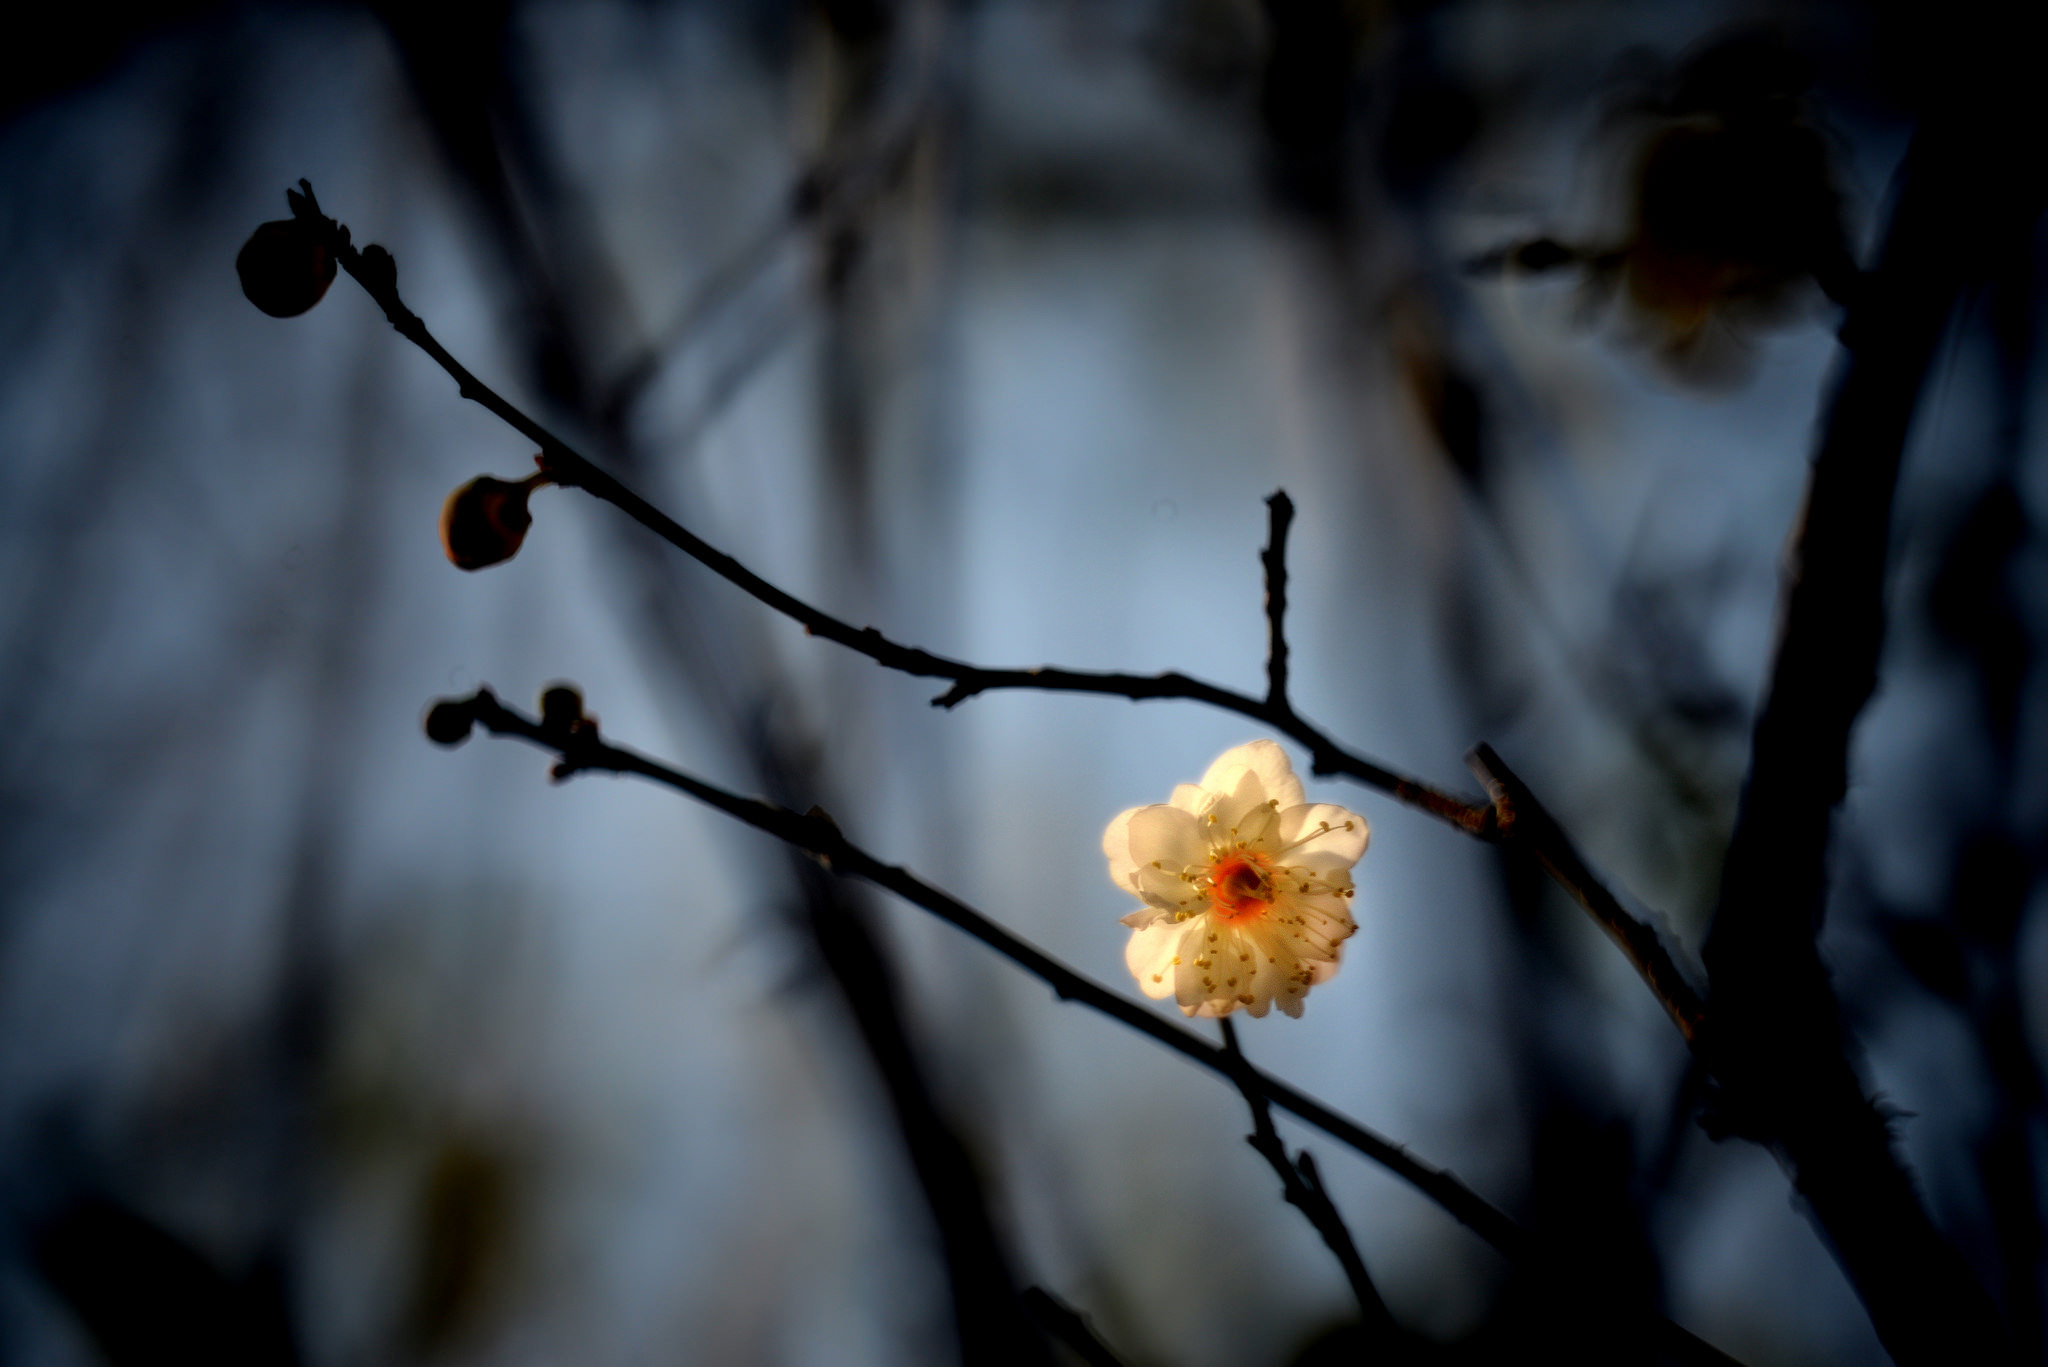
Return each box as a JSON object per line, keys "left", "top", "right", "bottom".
{"left": 428, "top": 689, "right": 1735, "bottom": 1367}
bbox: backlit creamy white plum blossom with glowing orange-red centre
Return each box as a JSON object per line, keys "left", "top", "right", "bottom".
{"left": 1102, "top": 740, "right": 1366, "bottom": 1017}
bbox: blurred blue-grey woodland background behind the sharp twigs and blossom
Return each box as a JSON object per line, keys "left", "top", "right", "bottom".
{"left": 0, "top": 0, "right": 2048, "bottom": 1367}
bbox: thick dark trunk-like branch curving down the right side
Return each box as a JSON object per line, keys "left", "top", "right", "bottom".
{"left": 1702, "top": 109, "right": 2044, "bottom": 1363}
